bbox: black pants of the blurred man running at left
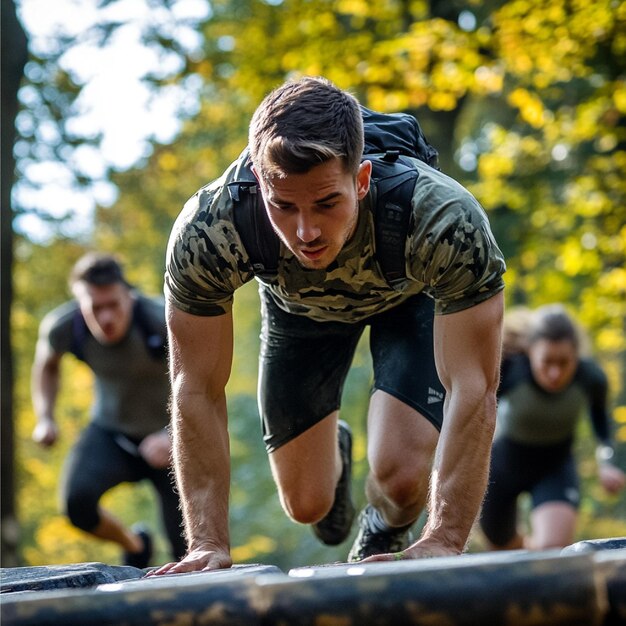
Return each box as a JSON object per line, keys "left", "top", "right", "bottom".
{"left": 61, "top": 424, "right": 186, "bottom": 560}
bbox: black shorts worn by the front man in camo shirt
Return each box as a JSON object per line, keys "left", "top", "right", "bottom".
{"left": 259, "top": 289, "right": 445, "bottom": 452}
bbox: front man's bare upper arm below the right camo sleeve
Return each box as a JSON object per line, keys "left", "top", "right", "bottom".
{"left": 434, "top": 292, "right": 504, "bottom": 393}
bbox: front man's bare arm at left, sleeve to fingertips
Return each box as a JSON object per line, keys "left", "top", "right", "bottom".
{"left": 154, "top": 304, "right": 233, "bottom": 574}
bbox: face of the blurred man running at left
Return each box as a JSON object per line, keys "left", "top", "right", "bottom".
{"left": 73, "top": 281, "right": 133, "bottom": 344}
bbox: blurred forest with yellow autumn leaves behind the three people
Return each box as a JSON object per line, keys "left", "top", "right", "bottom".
{"left": 2, "top": 0, "right": 626, "bottom": 568}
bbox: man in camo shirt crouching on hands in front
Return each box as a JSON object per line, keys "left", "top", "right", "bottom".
{"left": 155, "top": 78, "right": 504, "bottom": 574}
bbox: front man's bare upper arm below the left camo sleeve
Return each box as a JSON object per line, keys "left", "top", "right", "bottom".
{"left": 166, "top": 303, "right": 233, "bottom": 397}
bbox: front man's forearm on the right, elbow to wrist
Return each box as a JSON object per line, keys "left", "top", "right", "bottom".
{"left": 422, "top": 392, "right": 496, "bottom": 553}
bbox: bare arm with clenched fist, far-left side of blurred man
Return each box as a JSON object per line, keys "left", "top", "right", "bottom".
{"left": 31, "top": 337, "right": 63, "bottom": 447}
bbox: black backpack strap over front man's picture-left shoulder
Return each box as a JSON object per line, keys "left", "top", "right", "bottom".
{"left": 228, "top": 148, "right": 280, "bottom": 279}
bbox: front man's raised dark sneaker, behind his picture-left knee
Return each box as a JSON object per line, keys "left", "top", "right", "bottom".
{"left": 313, "top": 420, "right": 356, "bottom": 546}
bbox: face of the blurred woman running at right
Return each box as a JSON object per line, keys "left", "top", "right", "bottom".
{"left": 528, "top": 339, "right": 578, "bottom": 393}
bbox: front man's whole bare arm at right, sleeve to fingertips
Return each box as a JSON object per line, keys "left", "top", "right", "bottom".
{"left": 366, "top": 292, "right": 503, "bottom": 561}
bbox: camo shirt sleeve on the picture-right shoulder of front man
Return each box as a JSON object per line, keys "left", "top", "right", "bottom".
{"left": 407, "top": 165, "right": 506, "bottom": 314}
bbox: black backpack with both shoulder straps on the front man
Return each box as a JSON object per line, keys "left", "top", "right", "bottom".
{"left": 228, "top": 107, "right": 439, "bottom": 288}
